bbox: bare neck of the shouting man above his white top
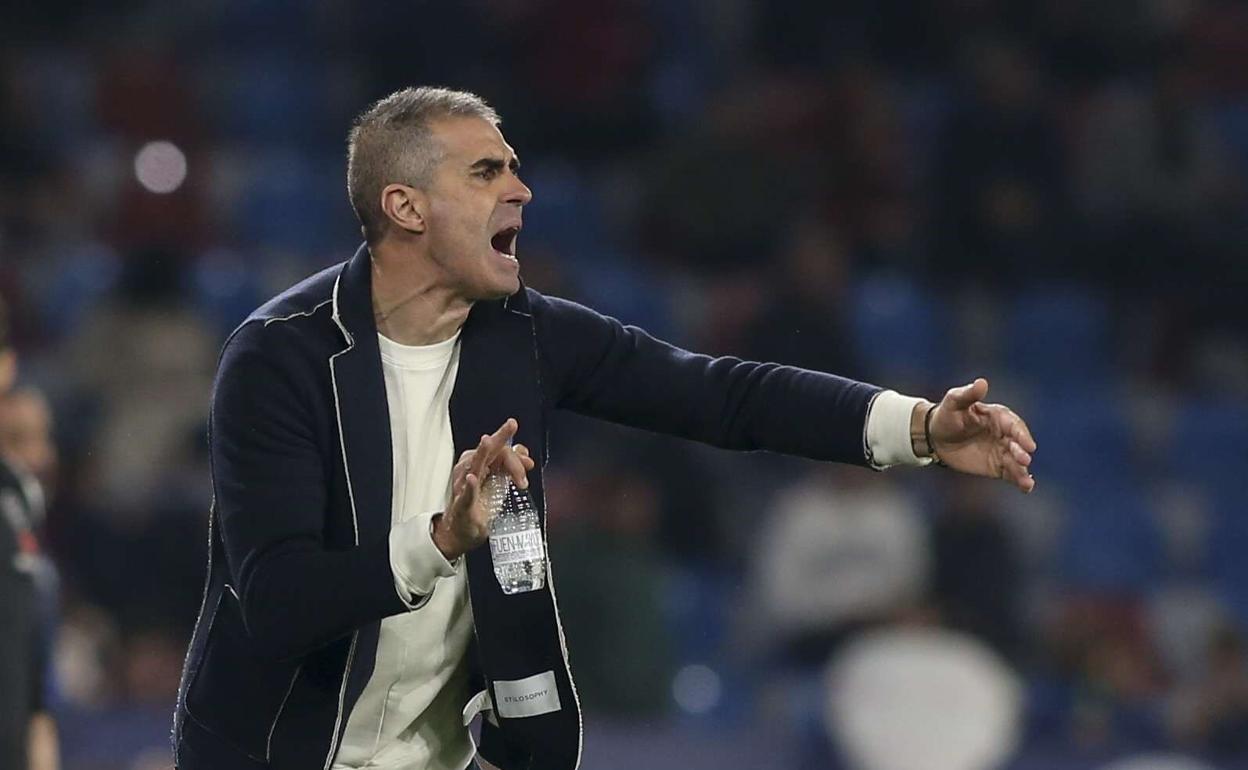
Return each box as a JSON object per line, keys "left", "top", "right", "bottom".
{"left": 371, "top": 243, "right": 472, "bottom": 344}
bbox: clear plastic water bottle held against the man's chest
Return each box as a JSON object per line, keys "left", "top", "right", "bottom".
{"left": 482, "top": 473, "right": 545, "bottom": 594}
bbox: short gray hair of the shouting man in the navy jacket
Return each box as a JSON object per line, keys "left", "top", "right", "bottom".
{"left": 347, "top": 86, "right": 502, "bottom": 243}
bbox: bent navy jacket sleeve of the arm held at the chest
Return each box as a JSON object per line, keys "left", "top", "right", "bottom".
{"left": 210, "top": 323, "right": 406, "bottom": 658}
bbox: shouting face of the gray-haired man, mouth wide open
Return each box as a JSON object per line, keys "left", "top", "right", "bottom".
{"left": 427, "top": 117, "right": 533, "bottom": 300}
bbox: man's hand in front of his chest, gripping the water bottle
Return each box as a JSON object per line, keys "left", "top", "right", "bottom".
{"left": 433, "top": 418, "right": 534, "bottom": 562}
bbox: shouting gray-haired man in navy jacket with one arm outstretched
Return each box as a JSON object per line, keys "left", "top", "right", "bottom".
{"left": 173, "top": 89, "right": 1035, "bottom": 770}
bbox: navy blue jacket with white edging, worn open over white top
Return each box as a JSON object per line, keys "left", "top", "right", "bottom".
{"left": 173, "top": 247, "right": 879, "bottom": 770}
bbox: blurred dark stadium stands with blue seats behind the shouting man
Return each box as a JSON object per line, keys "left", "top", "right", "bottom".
{"left": 0, "top": 0, "right": 1248, "bottom": 770}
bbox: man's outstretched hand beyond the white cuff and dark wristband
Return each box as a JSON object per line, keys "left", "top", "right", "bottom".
{"left": 931, "top": 377, "right": 1036, "bottom": 492}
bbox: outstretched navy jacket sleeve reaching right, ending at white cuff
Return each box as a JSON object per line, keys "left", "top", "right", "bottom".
{"left": 528, "top": 290, "right": 880, "bottom": 465}
